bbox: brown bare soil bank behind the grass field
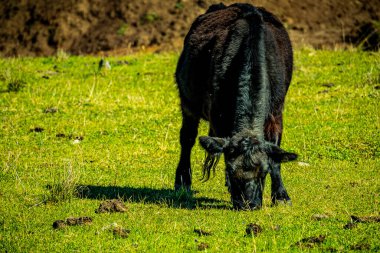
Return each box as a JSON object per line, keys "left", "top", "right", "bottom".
{"left": 0, "top": 0, "right": 380, "bottom": 56}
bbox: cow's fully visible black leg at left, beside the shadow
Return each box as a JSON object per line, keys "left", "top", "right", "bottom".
{"left": 174, "top": 113, "right": 199, "bottom": 191}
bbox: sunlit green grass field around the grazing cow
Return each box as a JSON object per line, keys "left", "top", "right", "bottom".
{"left": 0, "top": 49, "right": 380, "bottom": 252}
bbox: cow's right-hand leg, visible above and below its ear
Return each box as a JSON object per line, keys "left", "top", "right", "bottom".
{"left": 266, "top": 115, "right": 292, "bottom": 205}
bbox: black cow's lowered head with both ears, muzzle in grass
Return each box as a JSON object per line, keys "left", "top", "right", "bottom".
{"left": 199, "top": 133, "right": 297, "bottom": 209}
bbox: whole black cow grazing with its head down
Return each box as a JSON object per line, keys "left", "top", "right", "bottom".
{"left": 175, "top": 4, "right": 297, "bottom": 209}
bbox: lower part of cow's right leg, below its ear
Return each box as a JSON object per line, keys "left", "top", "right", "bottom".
{"left": 270, "top": 163, "right": 292, "bottom": 205}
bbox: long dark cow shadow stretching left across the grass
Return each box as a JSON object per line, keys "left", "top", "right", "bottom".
{"left": 77, "top": 185, "right": 232, "bottom": 209}
